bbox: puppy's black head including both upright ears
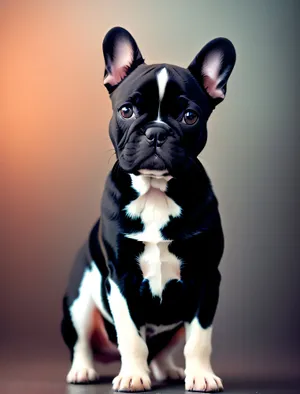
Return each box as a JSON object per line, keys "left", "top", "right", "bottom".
{"left": 103, "top": 27, "right": 235, "bottom": 176}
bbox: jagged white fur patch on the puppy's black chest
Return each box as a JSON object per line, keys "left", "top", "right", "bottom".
{"left": 126, "top": 177, "right": 181, "bottom": 297}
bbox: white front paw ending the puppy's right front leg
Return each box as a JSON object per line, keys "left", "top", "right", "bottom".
{"left": 185, "top": 370, "right": 224, "bottom": 393}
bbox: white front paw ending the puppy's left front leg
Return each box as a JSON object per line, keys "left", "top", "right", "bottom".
{"left": 112, "top": 371, "right": 151, "bottom": 392}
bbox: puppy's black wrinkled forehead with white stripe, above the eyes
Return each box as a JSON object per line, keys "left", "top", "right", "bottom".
{"left": 110, "top": 64, "right": 213, "bottom": 117}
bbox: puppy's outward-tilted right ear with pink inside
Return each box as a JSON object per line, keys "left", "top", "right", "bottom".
{"left": 188, "top": 38, "right": 236, "bottom": 105}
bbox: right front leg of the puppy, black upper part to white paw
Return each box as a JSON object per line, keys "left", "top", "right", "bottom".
{"left": 184, "top": 270, "right": 223, "bottom": 392}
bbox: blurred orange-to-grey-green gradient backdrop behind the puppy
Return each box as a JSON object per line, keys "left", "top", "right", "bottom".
{"left": 0, "top": 0, "right": 300, "bottom": 390}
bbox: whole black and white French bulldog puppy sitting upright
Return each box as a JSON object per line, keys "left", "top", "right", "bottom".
{"left": 61, "top": 27, "right": 236, "bottom": 392}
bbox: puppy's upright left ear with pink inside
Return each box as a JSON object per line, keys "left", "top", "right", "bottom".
{"left": 102, "top": 27, "right": 144, "bottom": 93}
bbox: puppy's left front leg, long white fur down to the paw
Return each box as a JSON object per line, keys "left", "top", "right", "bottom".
{"left": 108, "top": 281, "right": 151, "bottom": 391}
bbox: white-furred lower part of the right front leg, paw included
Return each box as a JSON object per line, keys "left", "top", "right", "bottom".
{"left": 184, "top": 318, "right": 223, "bottom": 391}
